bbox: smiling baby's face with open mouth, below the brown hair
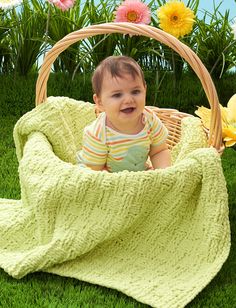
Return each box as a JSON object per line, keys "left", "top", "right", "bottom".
{"left": 94, "top": 72, "right": 146, "bottom": 132}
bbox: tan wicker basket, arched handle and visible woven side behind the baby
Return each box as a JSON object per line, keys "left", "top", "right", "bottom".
{"left": 36, "top": 22, "right": 223, "bottom": 152}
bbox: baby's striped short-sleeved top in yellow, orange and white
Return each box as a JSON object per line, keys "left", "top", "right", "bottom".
{"left": 77, "top": 107, "right": 168, "bottom": 172}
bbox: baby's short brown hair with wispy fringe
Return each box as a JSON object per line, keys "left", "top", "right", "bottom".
{"left": 92, "top": 56, "right": 146, "bottom": 96}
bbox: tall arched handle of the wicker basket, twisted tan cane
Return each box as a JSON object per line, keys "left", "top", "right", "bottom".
{"left": 35, "top": 22, "right": 222, "bottom": 150}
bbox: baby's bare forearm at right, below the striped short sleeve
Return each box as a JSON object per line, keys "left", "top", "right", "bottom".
{"left": 149, "top": 143, "right": 171, "bottom": 169}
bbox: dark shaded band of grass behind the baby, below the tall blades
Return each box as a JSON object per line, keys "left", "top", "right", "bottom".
{"left": 0, "top": 72, "right": 236, "bottom": 117}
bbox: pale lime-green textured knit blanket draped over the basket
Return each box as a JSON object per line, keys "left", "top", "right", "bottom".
{"left": 0, "top": 97, "right": 230, "bottom": 308}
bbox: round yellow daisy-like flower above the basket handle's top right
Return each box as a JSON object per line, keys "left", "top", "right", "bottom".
{"left": 157, "top": 1, "right": 195, "bottom": 38}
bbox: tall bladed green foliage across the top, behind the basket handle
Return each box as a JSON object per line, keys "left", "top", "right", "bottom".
{"left": 0, "top": 0, "right": 236, "bottom": 81}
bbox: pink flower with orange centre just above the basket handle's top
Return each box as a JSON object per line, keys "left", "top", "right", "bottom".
{"left": 115, "top": 0, "right": 151, "bottom": 24}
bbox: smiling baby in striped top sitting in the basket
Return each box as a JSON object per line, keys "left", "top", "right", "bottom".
{"left": 77, "top": 56, "right": 171, "bottom": 172}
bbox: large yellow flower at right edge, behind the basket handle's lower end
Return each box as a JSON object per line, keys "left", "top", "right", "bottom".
{"left": 195, "top": 94, "right": 236, "bottom": 147}
